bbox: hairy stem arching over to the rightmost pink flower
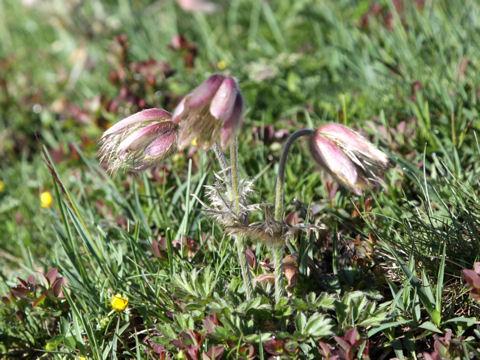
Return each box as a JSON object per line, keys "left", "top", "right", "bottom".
{"left": 272, "top": 129, "right": 313, "bottom": 304}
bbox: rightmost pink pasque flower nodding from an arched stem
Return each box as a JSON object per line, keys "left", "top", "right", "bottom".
{"left": 310, "top": 124, "right": 388, "bottom": 195}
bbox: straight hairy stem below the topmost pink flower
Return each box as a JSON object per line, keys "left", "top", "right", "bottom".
{"left": 230, "top": 136, "right": 253, "bottom": 299}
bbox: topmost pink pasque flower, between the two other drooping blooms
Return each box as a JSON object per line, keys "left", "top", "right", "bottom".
{"left": 172, "top": 75, "right": 243, "bottom": 150}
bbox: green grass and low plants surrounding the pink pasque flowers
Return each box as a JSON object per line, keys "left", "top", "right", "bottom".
{"left": 0, "top": 0, "right": 480, "bottom": 359}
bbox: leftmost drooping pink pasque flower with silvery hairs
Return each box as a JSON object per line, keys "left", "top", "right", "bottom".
{"left": 99, "top": 109, "right": 178, "bottom": 172}
